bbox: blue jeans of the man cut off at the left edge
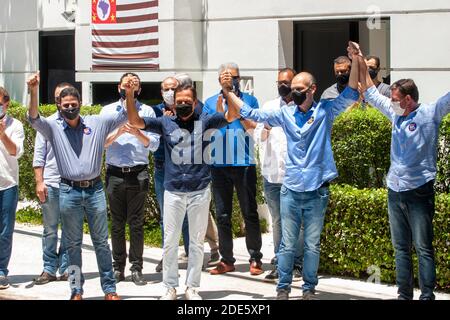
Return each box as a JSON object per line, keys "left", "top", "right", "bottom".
{"left": 0, "top": 186, "right": 19, "bottom": 276}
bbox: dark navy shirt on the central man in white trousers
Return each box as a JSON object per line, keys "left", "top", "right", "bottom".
{"left": 143, "top": 110, "right": 228, "bottom": 192}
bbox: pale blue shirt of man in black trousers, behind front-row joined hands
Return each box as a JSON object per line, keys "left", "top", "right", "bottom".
{"left": 100, "top": 99, "right": 159, "bottom": 168}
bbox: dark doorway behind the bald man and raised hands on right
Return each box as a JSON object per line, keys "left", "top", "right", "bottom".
{"left": 294, "top": 20, "right": 359, "bottom": 100}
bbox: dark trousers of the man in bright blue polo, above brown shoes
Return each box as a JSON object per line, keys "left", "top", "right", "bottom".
{"left": 211, "top": 166, "right": 262, "bottom": 264}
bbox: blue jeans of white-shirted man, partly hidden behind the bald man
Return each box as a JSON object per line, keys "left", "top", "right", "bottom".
{"left": 264, "top": 178, "right": 303, "bottom": 268}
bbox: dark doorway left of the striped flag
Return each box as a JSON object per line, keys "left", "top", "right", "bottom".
{"left": 39, "top": 30, "right": 81, "bottom": 103}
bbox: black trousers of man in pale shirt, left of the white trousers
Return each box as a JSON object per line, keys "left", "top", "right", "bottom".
{"left": 106, "top": 169, "right": 149, "bottom": 272}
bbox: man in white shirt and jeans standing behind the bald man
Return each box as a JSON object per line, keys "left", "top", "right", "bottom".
{"left": 254, "top": 68, "right": 303, "bottom": 281}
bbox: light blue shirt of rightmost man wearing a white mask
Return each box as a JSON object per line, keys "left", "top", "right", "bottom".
{"left": 365, "top": 86, "right": 450, "bottom": 192}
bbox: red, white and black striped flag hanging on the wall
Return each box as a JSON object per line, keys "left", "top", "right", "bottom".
{"left": 91, "top": 0, "right": 159, "bottom": 71}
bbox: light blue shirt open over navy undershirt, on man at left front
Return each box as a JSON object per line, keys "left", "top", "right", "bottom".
{"left": 28, "top": 111, "right": 127, "bottom": 181}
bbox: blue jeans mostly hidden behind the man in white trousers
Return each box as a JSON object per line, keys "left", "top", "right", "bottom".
{"left": 154, "top": 164, "right": 189, "bottom": 255}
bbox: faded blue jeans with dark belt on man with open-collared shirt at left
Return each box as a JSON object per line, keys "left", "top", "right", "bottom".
{"left": 59, "top": 182, "right": 116, "bottom": 294}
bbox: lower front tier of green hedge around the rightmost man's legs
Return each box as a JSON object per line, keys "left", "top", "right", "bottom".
{"left": 320, "top": 186, "right": 450, "bottom": 291}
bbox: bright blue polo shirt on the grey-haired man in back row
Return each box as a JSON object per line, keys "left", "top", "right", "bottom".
{"left": 203, "top": 92, "right": 258, "bottom": 167}
